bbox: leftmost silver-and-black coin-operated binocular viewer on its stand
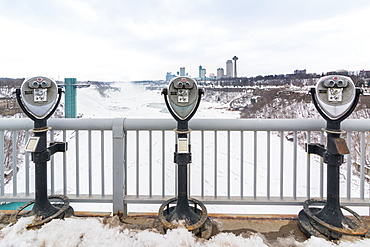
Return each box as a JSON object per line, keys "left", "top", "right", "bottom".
{"left": 13, "top": 76, "right": 73, "bottom": 227}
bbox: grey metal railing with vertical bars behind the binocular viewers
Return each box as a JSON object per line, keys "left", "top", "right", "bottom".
{"left": 0, "top": 118, "right": 370, "bottom": 212}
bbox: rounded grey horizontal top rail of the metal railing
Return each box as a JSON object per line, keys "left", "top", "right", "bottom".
{"left": 0, "top": 118, "right": 370, "bottom": 131}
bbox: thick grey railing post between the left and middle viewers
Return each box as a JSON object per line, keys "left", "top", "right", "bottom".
{"left": 112, "top": 118, "right": 127, "bottom": 214}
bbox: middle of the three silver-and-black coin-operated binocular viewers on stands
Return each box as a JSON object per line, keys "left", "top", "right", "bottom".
{"left": 155, "top": 76, "right": 212, "bottom": 238}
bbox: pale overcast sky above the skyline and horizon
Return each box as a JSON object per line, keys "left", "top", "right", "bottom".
{"left": 0, "top": 0, "right": 370, "bottom": 81}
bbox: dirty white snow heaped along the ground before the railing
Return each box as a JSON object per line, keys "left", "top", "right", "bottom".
{"left": 0, "top": 217, "right": 370, "bottom": 247}
